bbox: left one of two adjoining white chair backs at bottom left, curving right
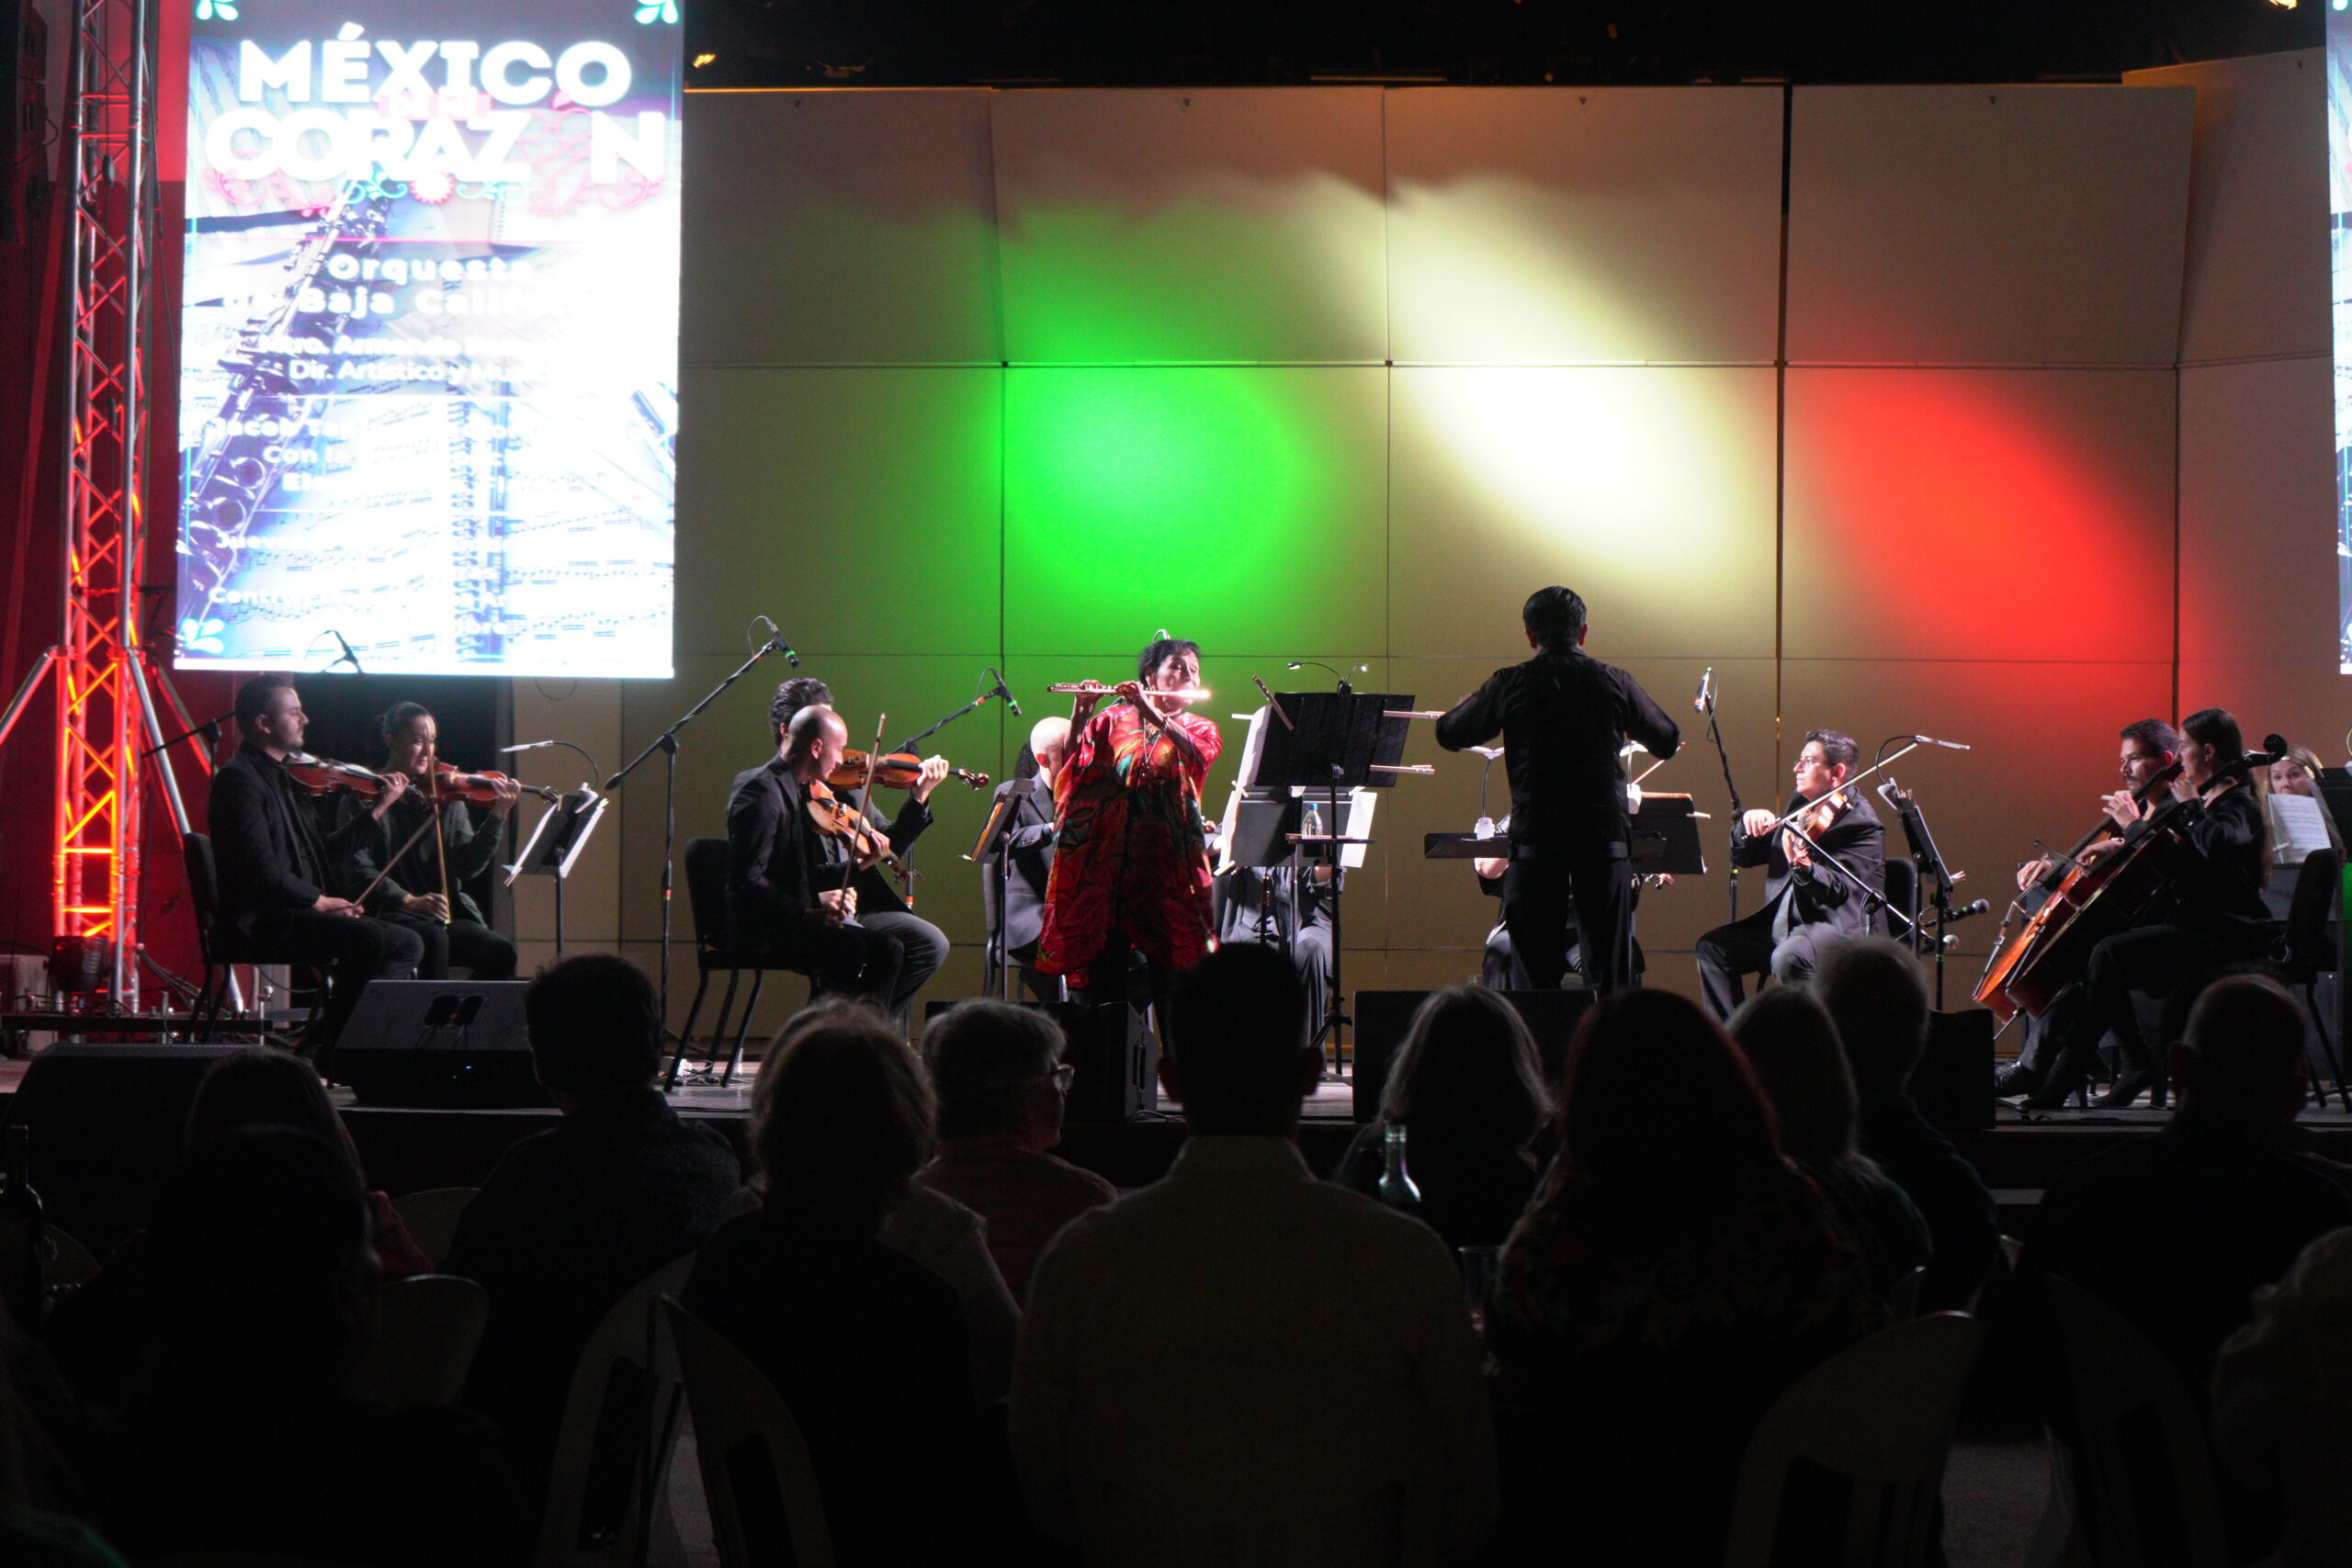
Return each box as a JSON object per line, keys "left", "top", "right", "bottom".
{"left": 532, "top": 1253, "right": 694, "bottom": 1568}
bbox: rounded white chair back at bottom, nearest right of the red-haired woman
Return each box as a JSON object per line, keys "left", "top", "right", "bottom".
{"left": 1724, "top": 1312, "right": 1985, "bottom": 1568}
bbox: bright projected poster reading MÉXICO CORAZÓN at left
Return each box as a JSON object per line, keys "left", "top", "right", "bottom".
{"left": 164, "top": 0, "right": 682, "bottom": 677}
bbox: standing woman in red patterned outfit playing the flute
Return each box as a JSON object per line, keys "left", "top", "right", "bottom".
{"left": 1037, "top": 637, "right": 1223, "bottom": 1030}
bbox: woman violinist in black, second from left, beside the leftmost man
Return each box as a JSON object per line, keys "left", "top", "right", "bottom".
{"left": 345, "top": 703, "right": 522, "bottom": 980}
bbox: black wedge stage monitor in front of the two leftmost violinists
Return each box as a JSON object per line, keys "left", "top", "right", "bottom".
{"left": 327, "top": 980, "right": 553, "bottom": 1110}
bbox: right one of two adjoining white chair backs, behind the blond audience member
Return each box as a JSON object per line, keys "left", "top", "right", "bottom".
{"left": 663, "top": 1303, "right": 837, "bottom": 1568}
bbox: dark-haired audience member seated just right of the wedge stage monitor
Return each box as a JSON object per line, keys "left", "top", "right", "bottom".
{"left": 442, "top": 952, "right": 741, "bottom": 1506}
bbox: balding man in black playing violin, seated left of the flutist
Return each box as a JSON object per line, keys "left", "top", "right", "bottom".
{"left": 727, "top": 705, "right": 929, "bottom": 1009}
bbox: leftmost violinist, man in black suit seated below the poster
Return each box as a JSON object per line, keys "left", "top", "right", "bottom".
{"left": 207, "top": 674, "right": 424, "bottom": 1060}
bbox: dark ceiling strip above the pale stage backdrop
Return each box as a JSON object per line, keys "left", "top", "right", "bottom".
{"left": 687, "top": 0, "right": 2326, "bottom": 87}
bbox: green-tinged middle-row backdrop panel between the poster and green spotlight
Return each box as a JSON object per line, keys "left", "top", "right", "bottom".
{"left": 677, "top": 367, "right": 1004, "bottom": 663}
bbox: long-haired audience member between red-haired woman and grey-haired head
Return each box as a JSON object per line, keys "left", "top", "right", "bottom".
{"left": 1724, "top": 985, "right": 1931, "bottom": 1295}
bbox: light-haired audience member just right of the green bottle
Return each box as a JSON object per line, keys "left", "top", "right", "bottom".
{"left": 1336, "top": 985, "right": 1553, "bottom": 1248}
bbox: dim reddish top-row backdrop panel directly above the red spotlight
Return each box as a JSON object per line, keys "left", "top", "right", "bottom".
{"left": 1788, "top": 87, "right": 2192, "bottom": 365}
